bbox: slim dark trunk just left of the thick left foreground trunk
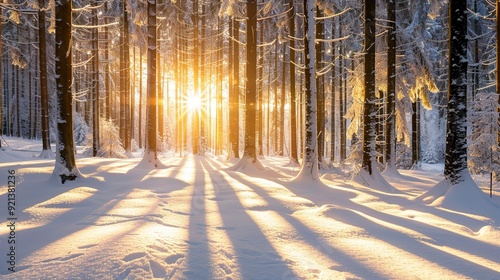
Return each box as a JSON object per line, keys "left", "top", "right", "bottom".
{"left": 38, "top": 0, "right": 52, "bottom": 157}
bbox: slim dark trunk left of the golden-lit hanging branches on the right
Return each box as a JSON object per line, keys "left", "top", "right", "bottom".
{"left": 385, "top": 0, "right": 396, "bottom": 169}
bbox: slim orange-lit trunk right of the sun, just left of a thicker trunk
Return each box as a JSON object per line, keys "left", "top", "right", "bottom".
{"left": 229, "top": 20, "right": 240, "bottom": 158}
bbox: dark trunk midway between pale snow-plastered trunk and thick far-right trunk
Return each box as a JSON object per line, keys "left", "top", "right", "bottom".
{"left": 361, "top": 0, "right": 377, "bottom": 175}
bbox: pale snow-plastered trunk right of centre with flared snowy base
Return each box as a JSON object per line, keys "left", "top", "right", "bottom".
{"left": 297, "top": 0, "right": 319, "bottom": 181}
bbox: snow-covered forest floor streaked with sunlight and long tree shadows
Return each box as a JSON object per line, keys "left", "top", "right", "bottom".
{"left": 0, "top": 138, "right": 500, "bottom": 279}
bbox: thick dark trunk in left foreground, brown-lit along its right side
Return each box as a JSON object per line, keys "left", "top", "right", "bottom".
{"left": 54, "top": 0, "right": 79, "bottom": 184}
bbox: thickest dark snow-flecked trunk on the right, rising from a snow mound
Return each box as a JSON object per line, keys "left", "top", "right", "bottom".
{"left": 444, "top": 0, "right": 468, "bottom": 185}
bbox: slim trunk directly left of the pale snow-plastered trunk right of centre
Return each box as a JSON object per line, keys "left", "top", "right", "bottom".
{"left": 288, "top": 1, "right": 299, "bottom": 163}
